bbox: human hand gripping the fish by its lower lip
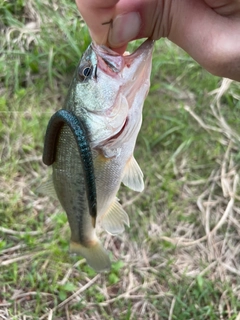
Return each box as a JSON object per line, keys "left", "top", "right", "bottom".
{"left": 76, "top": 0, "right": 240, "bottom": 81}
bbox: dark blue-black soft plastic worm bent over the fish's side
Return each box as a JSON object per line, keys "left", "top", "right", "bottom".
{"left": 43, "top": 109, "right": 97, "bottom": 227}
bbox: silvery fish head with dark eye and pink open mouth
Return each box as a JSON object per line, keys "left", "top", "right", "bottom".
{"left": 67, "top": 40, "right": 154, "bottom": 147}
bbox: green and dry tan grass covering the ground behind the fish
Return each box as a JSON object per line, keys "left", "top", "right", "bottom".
{"left": 0, "top": 0, "right": 240, "bottom": 320}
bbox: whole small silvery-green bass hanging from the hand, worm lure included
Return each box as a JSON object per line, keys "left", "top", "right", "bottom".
{"left": 42, "top": 39, "right": 154, "bottom": 272}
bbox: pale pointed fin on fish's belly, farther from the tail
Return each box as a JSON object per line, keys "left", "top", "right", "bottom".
{"left": 122, "top": 156, "right": 144, "bottom": 192}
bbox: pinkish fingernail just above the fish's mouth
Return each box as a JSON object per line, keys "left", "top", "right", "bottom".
{"left": 108, "top": 12, "right": 141, "bottom": 47}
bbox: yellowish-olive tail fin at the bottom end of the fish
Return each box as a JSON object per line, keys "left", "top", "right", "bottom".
{"left": 70, "top": 241, "right": 111, "bottom": 272}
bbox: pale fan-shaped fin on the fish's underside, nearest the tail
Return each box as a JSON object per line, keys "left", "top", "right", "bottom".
{"left": 102, "top": 198, "right": 129, "bottom": 235}
